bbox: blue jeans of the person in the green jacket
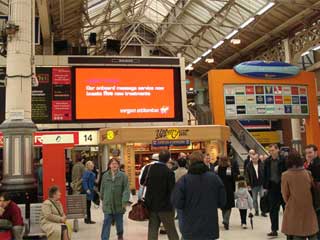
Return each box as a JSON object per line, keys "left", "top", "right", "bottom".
{"left": 101, "top": 213, "right": 123, "bottom": 240}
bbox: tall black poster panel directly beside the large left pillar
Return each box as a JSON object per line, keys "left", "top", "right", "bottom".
{"left": 31, "top": 68, "right": 51, "bottom": 123}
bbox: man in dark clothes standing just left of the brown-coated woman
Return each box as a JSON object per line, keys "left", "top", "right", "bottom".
{"left": 263, "top": 144, "right": 287, "bottom": 237}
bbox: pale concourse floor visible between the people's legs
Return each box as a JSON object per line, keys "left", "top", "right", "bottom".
{"left": 72, "top": 201, "right": 286, "bottom": 240}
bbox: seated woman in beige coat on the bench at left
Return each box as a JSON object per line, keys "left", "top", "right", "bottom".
{"left": 40, "top": 186, "right": 71, "bottom": 240}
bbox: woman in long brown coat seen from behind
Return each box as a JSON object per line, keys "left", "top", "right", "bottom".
{"left": 281, "top": 152, "right": 318, "bottom": 240}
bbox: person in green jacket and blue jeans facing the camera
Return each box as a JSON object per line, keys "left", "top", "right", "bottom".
{"left": 100, "top": 158, "right": 130, "bottom": 240}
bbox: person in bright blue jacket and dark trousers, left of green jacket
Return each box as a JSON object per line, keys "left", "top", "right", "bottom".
{"left": 82, "top": 161, "right": 96, "bottom": 224}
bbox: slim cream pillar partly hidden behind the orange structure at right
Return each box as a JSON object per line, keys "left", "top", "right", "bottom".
{"left": 283, "top": 39, "right": 302, "bottom": 154}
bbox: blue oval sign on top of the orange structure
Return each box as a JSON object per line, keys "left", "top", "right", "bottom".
{"left": 234, "top": 61, "right": 300, "bottom": 79}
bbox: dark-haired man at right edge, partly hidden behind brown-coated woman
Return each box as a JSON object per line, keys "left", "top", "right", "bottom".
{"left": 305, "top": 144, "right": 320, "bottom": 240}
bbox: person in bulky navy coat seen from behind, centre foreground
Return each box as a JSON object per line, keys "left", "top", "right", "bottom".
{"left": 171, "top": 151, "right": 226, "bottom": 240}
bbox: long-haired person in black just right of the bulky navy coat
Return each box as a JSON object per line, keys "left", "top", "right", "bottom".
{"left": 215, "top": 156, "right": 239, "bottom": 230}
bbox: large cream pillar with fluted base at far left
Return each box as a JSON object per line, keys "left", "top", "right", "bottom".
{"left": 0, "top": 0, "right": 36, "bottom": 203}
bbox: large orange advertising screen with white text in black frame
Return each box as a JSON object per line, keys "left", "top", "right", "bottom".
{"left": 75, "top": 68, "right": 182, "bottom": 121}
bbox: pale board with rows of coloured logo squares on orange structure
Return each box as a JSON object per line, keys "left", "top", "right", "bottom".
{"left": 224, "top": 84, "right": 309, "bottom": 119}
